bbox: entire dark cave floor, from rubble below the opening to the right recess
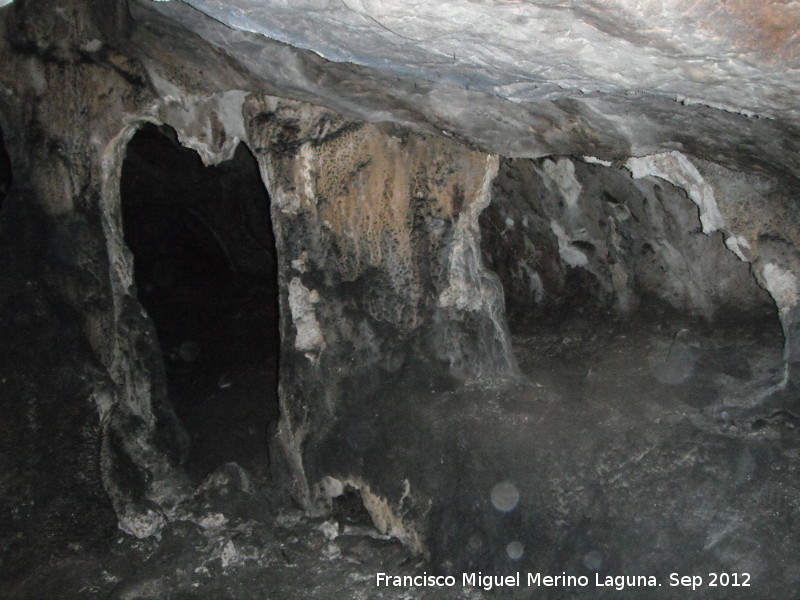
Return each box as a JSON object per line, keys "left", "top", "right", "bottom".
{"left": 0, "top": 308, "right": 800, "bottom": 599}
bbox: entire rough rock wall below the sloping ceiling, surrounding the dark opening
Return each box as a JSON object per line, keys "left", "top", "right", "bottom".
{"left": 0, "top": 0, "right": 800, "bottom": 552}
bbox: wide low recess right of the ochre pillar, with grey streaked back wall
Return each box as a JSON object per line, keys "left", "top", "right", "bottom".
{"left": 481, "top": 157, "right": 783, "bottom": 408}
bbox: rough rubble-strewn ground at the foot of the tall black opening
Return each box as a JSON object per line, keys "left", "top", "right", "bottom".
{"left": 0, "top": 463, "right": 450, "bottom": 600}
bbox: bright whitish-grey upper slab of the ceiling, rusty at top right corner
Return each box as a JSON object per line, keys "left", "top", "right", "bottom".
{"left": 145, "top": 0, "right": 800, "bottom": 111}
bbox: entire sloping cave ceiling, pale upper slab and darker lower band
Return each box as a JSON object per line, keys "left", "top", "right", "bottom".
{"left": 131, "top": 0, "right": 800, "bottom": 178}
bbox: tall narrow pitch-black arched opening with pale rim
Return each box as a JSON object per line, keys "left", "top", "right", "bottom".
{"left": 121, "top": 124, "right": 279, "bottom": 477}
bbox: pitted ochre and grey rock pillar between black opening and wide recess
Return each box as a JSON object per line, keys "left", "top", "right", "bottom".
{"left": 245, "top": 97, "right": 516, "bottom": 506}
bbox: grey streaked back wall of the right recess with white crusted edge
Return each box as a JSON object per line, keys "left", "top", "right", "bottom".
{"left": 481, "top": 152, "right": 800, "bottom": 403}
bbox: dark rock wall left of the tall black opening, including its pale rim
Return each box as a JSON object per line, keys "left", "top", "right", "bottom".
{"left": 0, "top": 3, "right": 197, "bottom": 536}
